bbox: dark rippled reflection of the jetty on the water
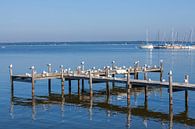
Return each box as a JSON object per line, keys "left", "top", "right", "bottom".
{"left": 10, "top": 88, "right": 195, "bottom": 129}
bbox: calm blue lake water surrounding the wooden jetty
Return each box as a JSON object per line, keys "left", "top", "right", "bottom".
{"left": 0, "top": 42, "right": 195, "bottom": 129}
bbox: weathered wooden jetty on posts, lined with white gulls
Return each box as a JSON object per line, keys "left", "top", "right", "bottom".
{"left": 9, "top": 61, "right": 195, "bottom": 110}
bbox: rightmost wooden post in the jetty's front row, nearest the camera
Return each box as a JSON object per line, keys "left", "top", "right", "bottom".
{"left": 169, "top": 71, "right": 173, "bottom": 106}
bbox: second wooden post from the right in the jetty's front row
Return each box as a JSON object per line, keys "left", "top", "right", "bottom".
{"left": 127, "top": 69, "right": 131, "bottom": 108}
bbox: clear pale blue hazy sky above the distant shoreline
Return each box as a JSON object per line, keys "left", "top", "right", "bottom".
{"left": 0, "top": 0, "right": 195, "bottom": 42}
